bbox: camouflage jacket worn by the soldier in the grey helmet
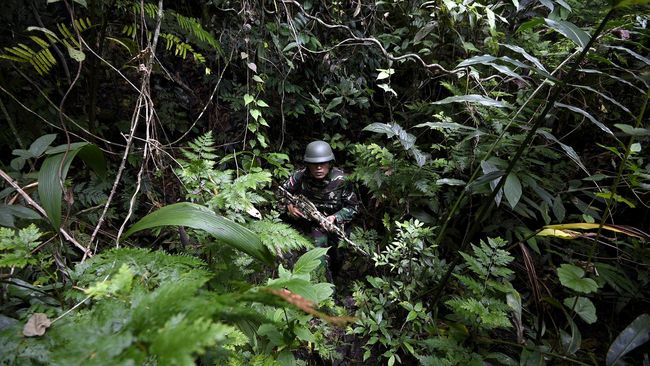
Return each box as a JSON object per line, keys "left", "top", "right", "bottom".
{"left": 282, "top": 168, "right": 359, "bottom": 223}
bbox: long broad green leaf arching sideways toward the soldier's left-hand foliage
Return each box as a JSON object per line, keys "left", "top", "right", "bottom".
{"left": 123, "top": 202, "right": 273, "bottom": 264}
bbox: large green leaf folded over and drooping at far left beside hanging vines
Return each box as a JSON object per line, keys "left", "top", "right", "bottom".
{"left": 38, "top": 142, "right": 106, "bottom": 230}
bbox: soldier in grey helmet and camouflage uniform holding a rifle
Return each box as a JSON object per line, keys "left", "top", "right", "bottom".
{"left": 283, "top": 141, "right": 358, "bottom": 282}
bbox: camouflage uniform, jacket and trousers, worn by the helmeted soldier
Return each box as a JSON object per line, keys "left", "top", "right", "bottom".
{"left": 282, "top": 167, "right": 359, "bottom": 282}
